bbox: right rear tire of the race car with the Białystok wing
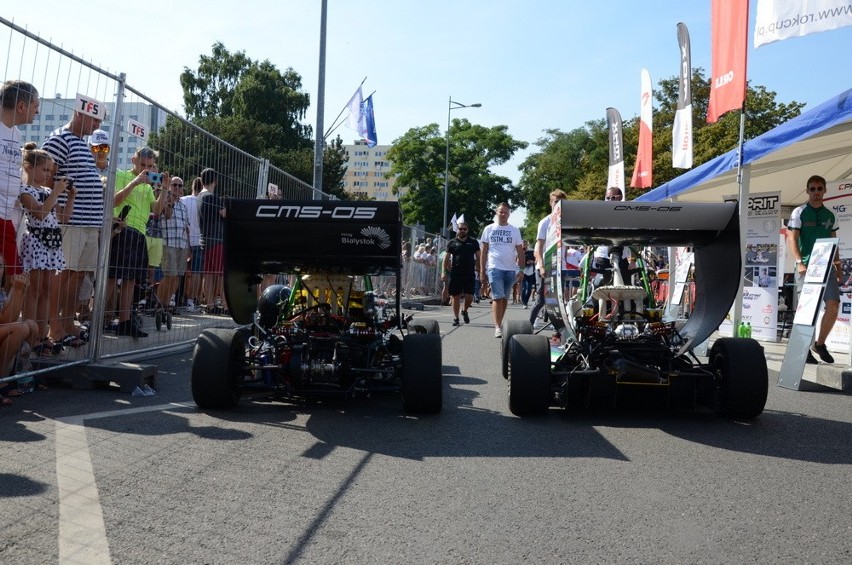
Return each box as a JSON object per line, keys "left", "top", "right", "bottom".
{"left": 400, "top": 333, "right": 443, "bottom": 414}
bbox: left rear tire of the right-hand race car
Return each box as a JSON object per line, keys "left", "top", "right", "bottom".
{"left": 508, "top": 334, "right": 553, "bottom": 416}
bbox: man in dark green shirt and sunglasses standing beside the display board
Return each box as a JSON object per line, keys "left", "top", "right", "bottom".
{"left": 787, "top": 175, "right": 840, "bottom": 365}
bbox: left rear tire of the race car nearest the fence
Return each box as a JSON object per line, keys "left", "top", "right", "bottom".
{"left": 191, "top": 328, "right": 246, "bottom": 410}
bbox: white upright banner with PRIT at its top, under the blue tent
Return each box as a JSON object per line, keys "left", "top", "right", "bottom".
{"left": 722, "top": 191, "right": 784, "bottom": 341}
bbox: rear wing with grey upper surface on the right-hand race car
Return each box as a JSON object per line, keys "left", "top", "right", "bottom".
{"left": 547, "top": 200, "right": 742, "bottom": 350}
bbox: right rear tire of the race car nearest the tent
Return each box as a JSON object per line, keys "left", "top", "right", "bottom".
{"left": 709, "top": 338, "right": 769, "bottom": 420}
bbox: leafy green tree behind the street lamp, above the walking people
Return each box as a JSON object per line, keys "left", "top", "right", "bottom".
{"left": 387, "top": 119, "right": 527, "bottom": 233}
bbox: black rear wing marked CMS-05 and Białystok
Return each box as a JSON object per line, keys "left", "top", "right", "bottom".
{"left": 224, "top": 199, "right": 402, "bottom": 323}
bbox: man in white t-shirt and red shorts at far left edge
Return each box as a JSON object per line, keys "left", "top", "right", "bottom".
{"left": 0, "top": 80, "right": 39, "bottom": 280}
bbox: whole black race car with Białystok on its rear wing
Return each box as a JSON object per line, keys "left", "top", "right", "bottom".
{"left": 192, "top": 200, "right": 442, "bottom": 414}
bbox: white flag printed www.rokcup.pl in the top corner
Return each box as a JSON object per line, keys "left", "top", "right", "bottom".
{"left": 754, "top": 0, "right": 852, "bottom": 47}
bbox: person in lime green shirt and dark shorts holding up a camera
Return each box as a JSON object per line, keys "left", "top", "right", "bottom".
{"left": 107, "top": 147, "right": 171, "bottom": 337}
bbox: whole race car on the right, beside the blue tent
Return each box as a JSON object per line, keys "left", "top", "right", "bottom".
{"left": 501, "top": 201, "right": 768, "bottom": 419}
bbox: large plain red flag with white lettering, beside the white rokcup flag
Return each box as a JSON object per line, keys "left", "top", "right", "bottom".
{"left": 707, "top": 0, "right": 748, "bottom": 124}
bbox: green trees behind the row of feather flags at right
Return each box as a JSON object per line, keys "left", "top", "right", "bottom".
{"left": 519, "top": 68, "right": 804, "bottom": 237}
